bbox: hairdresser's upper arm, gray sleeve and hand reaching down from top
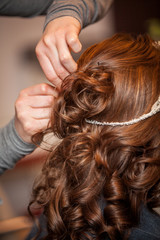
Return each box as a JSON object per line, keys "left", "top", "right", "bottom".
{"left": 36, "top": 0, "right": 113, "bottom": 86}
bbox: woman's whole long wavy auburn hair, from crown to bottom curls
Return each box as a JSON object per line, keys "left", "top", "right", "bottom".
{"left": 29, "top": 34, "right": 160, "bottom": 240}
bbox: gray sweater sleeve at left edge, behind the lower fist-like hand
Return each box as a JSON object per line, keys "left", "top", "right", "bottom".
{"left": 0, "top": 119, "right": 36, "bottom": 175}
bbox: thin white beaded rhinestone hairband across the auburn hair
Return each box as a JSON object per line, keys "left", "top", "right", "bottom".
{"left": 85, "top": 96, "right": 160, "bottom": 127}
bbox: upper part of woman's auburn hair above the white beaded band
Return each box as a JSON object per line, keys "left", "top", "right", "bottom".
{"left": 53, "top": 34, "right": 160, "bottom": 142}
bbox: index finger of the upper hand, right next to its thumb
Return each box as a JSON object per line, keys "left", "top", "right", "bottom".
{"left": 57, "top": 35, "right": 77, "bottom": 73}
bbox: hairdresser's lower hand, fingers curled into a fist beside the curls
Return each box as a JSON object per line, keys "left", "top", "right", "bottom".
{"left": 15, "top": 83, "right": 57, "bottom": 143}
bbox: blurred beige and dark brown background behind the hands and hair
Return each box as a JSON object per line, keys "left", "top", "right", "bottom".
{"left": 0, "top": 0, "right": 160, "bottom": 240}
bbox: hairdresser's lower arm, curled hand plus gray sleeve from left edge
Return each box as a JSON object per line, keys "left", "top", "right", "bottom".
{"left": 0, "top": 84, "right": 57, "bottom": 174}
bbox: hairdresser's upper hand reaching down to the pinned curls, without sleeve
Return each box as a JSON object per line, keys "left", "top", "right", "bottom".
{"left": 36, "top": 16, "right": 82, "bottom": 87}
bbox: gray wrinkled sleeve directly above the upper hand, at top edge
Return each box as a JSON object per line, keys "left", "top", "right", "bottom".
{"left": 45, "top": 0, "right": 113, "bottom": 28}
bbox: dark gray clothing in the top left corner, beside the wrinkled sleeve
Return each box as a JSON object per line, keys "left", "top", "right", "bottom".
{"left": 0, "top": 0, "right": 53, "bottom": 17}
